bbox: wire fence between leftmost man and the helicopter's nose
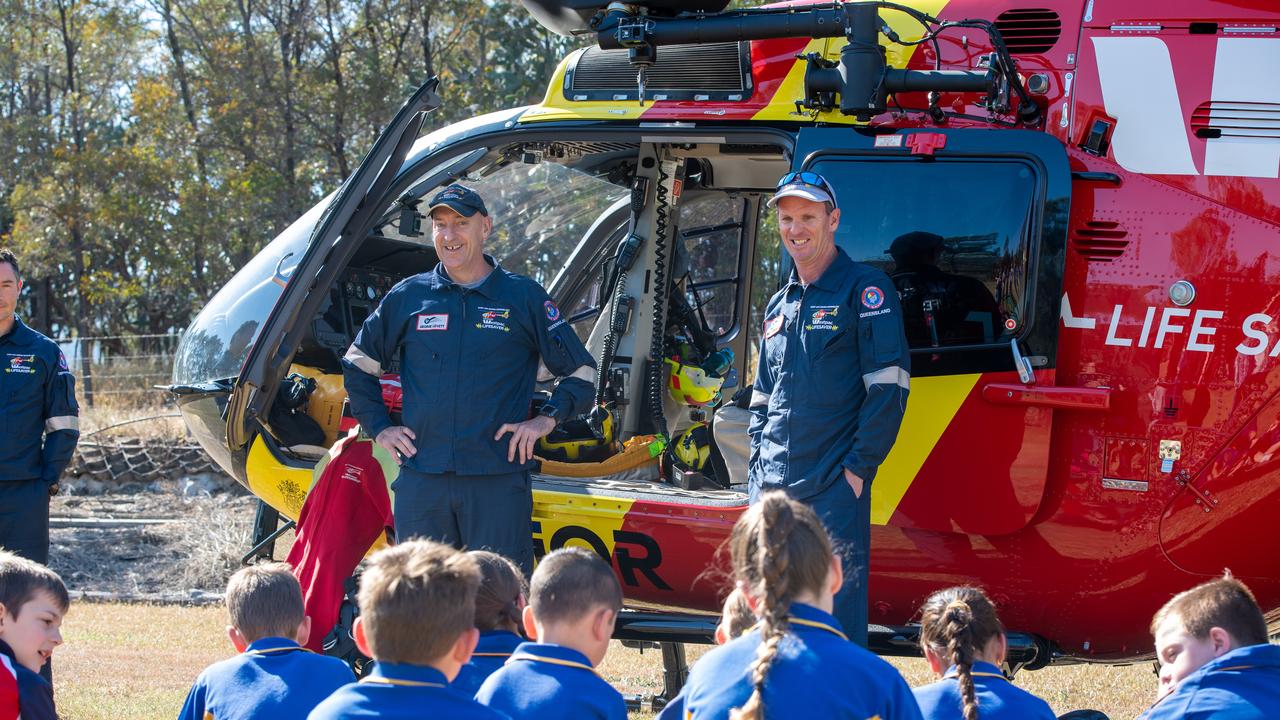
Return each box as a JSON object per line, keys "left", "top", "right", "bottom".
{"left": 55, "top": 333, "right": 182, "bottom": 407}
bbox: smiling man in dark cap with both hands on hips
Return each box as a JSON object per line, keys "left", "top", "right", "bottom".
{"left": 343, "top": 184, "right": 595, "bottom": 575}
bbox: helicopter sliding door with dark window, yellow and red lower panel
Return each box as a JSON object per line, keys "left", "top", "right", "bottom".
{"left": 794, "top": 128, "right": 1080, "bottom": 534}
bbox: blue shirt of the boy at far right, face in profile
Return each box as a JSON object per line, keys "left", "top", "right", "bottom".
{"left": 1139, "top": 644, "right": 1280, "bottom": 720}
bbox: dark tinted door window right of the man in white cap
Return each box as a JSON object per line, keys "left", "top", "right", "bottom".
{"left": 813, "top": 159, "right": 1039, "bottom": 348}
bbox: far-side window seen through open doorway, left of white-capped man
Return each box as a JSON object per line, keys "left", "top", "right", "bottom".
{"left": 676, "top": 193, "right": 745, "bottom": 337}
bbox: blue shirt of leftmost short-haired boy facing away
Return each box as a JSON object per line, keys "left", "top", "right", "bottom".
{"left": 178, "top": 638, "right": 355, "bottom": 720}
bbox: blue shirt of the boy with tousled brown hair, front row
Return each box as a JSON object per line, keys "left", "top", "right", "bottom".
{"left": 307, "top": 662, "right": 511, "bottom": 720}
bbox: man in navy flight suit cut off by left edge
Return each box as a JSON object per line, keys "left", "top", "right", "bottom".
{"left": 0, "top": 250, "right": 79, "bottom": 565}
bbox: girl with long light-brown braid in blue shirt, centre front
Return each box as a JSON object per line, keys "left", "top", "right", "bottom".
{"left": 678, "top": 491, "right": 920, "bottom": 720}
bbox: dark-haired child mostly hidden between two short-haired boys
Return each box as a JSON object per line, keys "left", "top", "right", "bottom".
{"left": 449, "top": 550, "right": 529, "bottom": 697}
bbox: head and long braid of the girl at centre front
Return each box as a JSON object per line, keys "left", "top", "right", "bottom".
{"left": 728, "top": 491, "right": 832, "bottom": 720}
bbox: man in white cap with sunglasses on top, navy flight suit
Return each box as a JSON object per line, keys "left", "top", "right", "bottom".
{"left": 748, "top": 172, "right": 910, "bottom": 646}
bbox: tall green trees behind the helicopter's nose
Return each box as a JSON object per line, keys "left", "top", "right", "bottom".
{"left": 0, "top": 0, "right": 580, "bottom": 336}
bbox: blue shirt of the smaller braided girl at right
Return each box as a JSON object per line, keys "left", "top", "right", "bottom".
{"left": 914, "top": 662, "right": 1057, "bottom": 720}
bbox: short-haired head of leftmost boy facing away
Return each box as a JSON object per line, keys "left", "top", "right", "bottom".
{"left": 227, "top": 562, "right": 306, "bottom": 643}
